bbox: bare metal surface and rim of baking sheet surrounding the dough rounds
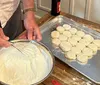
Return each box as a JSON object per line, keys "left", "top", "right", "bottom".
{"left": 40, "top": 15, "right": 100, "bottom": 84}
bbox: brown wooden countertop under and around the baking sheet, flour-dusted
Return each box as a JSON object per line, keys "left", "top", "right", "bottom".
{"left": 19, "top": 12, "right": 100, "bottom": 85}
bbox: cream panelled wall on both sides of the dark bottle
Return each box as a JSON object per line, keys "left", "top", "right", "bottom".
{"left": 35, "top": 0, "right": 100, "bottom": 24}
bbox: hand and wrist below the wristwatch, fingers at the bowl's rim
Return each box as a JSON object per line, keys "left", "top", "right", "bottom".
{"left": 19, "top": 11, "right": 42, "bottom": 41}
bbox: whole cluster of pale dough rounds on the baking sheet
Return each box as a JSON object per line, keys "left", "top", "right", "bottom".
{"left": 51, "top": 24, "right": 100, "bottom": 63}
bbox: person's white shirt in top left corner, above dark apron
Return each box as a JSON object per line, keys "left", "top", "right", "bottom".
{"left": 0, "top": 0, "right": 20, "bottom": 27}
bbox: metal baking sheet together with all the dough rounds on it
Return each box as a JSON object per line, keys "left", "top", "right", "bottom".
{"left": 40, "top": 15, "right": 100, "bottom": 84}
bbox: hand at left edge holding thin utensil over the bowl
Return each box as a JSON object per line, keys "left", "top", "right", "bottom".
{"left": 0, "top": 28, "right": 10, "bottom": 47}
